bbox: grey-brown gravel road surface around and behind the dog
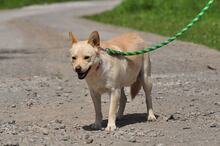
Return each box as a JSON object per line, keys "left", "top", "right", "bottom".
{"left": 0, "top": 0, "right": 220, "bottom": 146}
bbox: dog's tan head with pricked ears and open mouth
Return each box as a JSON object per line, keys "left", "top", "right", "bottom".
{"left": 69, "top": 31, "right": 100, "bottom": 79}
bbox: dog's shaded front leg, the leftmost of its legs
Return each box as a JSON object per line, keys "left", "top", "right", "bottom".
{"left": 90, "top": 90, "right": 102, "bottom": 130}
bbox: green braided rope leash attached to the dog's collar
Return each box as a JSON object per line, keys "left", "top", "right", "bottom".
{"left": 106, "top": 0, "right": 214, "bottom": 56}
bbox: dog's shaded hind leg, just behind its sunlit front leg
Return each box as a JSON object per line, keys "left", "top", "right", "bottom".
{"left": 117, "top": 88, "right": 127, "bottom": 119}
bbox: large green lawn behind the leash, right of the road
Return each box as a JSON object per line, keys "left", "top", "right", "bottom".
{"left": 86, "top": 0, "right": 220, "bottom": 50}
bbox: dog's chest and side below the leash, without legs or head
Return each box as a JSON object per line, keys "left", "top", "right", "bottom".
{"left": 87, "top": 53, "right": 141, "bottom": 93}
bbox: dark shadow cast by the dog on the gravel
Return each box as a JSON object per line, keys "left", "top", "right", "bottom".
{"left": 82, "top": 113, "right": 159, "bottom": 131}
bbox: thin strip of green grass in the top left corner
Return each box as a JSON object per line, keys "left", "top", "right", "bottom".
{"left": 0, "top": 0, "right": 81, "bottom": 9}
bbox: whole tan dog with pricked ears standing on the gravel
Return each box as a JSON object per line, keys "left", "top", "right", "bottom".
{"left": 70, "top": 31, "right": 156, "bottom": 131}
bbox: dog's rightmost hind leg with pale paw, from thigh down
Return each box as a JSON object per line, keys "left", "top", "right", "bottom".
{"left": 140, "top": 54, "right": 156, "bottom": 121}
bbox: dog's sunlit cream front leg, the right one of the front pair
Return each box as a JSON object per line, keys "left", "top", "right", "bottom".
{"left": 105, "top": 89, "right": 121, "bottom": 131}
